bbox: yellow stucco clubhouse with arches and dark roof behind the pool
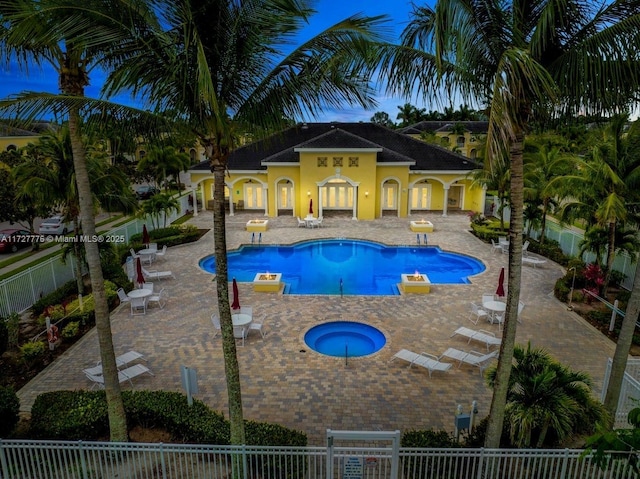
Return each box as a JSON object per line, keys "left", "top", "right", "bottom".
{"left": 189, "top": 123, "right": 485, "bottom": 220}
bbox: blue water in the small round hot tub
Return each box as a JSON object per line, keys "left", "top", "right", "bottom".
{"left": 304, "top": 321, "right": 387, "bottom": 358}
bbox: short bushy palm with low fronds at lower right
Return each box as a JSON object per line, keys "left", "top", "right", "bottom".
{"left": 487, "top": 343, "right": 606, "bottom": 448}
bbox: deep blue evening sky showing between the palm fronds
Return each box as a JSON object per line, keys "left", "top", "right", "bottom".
{"left": 0, "top": 0, "right": 432, "bottom": 121}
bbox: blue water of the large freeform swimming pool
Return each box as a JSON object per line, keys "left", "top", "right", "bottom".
{"left": 200, "top": 239, "right": 485, "bottom": 296}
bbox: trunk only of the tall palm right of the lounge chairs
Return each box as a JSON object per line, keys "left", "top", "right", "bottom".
{"left": 484, "top": 133, "right": 524, "bottom": 448}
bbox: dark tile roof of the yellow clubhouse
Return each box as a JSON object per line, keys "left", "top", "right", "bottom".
{"left": 191, "top": 122, "right": 478, "bottom": 172}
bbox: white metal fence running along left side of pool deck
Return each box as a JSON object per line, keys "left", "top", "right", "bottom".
{"left": 0, "top": 194, "right": 189, "bottom": 317}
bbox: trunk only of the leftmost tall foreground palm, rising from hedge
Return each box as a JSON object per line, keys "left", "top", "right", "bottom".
{"left": 66, "top": 79, "right": 128, "bottom": 442}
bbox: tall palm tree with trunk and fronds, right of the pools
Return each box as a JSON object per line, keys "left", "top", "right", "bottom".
{"left": 383, "top": 0, "right": 640, "bottom": 447}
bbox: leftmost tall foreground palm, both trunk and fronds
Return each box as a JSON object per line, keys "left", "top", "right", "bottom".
{"left": 0, "top": 0, "right": 154, "bottom": 441}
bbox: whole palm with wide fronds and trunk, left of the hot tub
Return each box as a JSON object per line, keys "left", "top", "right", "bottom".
{"left": 74, "top": 0, "right": 384, "bottom": 444}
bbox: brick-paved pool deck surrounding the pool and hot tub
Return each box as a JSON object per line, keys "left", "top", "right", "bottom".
{"left": 18, "top": 211, "right": 615, "bottom": 445}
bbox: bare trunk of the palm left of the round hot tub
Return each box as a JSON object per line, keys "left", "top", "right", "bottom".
{"left": 212, "top": 161, "right": 245, "bottom": 444}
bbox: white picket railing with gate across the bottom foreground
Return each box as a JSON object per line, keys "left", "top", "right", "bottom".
{"left": 0, "top": 440, "right": 638, "bottom": 479}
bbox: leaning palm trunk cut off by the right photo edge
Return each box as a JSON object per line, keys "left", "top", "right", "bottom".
{"left": 604, "top": 256, "right": 640, "bottom": 428}
